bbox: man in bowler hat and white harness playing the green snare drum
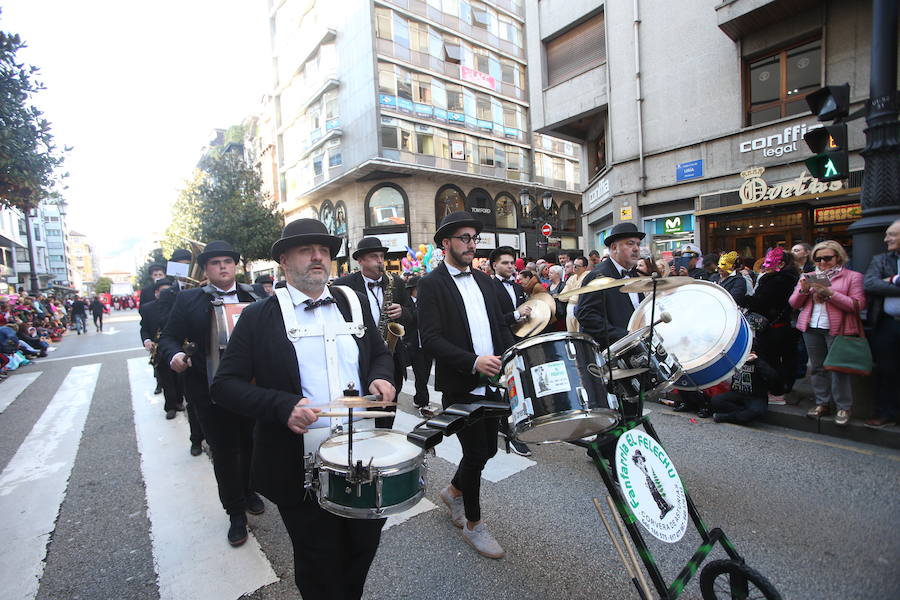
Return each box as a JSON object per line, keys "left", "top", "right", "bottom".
{"left": 212, "top": 219, "right": 395, "bottom": 600}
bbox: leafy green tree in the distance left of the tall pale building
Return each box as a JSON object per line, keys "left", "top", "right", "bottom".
{"left": 163, "top": 152, "right": 284, "bottom": 271}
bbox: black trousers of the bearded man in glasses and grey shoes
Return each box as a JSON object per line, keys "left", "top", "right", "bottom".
{"left": 441, "top": 390, "right": 502, "bottom": 521}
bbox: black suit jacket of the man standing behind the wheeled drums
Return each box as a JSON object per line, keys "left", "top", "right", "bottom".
{"left": 575, "top": 257, "right": 634, "bottom": 348}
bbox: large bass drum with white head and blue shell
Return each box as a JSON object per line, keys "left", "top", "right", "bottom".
{"left": 628, "top": 281, "right": 753, "bottom": 390}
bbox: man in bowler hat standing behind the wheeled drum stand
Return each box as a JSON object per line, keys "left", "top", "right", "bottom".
{"left": 575, "top": 223, "right": 645, "bottom": 348}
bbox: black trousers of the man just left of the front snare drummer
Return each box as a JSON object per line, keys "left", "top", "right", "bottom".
{"left": 193, "top": 400, "right": 253, "bottom": 515}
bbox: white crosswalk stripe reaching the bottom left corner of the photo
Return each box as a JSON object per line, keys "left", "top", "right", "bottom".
{"left": 0, "top": 364, "right": 100, "bottom": 600}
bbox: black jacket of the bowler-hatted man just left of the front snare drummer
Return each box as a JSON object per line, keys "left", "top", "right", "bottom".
{"left": 157, "top": 283, "right": 256, "bottom": 403}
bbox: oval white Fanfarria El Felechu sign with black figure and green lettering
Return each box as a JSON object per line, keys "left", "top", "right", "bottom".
{"left": 616, "top": 429, "right": 688, "bottom": 544}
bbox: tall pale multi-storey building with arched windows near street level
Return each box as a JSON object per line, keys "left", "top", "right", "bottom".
{"left": 260, "top": 0, "right": 582, "bottom": 268}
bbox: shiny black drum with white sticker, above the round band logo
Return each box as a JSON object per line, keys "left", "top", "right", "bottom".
{"left": 503, "top": 331, "right": 619, "bottom": 444}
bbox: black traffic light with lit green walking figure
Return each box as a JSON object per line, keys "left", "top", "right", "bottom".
{"left": 803, "top": 83, "right": 850, "bottom": 182}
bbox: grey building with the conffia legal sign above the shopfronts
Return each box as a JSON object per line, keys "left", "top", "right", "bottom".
{"left": 526, "top": 0, "right": 884, "bottom": 259}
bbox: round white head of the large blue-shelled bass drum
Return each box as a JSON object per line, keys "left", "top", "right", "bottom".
{"left": 628, "top": 281, "right": 741, "bottom": 371}
